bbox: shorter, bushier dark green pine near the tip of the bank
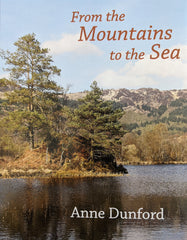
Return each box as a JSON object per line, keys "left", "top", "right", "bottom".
{"left": 75, "top": 81, "right": 123, "bottom": 160}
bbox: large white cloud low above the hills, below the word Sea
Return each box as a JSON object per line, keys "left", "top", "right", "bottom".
{"left": 95, "top": 46, "right": 187, "bottom": 88}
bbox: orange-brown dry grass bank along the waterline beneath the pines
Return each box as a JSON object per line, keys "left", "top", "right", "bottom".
{"left": 0, "top": 149, "right": 120, "bottom": 178}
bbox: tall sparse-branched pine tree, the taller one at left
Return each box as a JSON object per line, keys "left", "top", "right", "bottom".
{"left": 1, "top": 34, "right": 63, "bottom": 149}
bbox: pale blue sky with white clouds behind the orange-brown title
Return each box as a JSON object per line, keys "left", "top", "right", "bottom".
{"left": 0, "top": 0, "right": 187, "bottom": 92}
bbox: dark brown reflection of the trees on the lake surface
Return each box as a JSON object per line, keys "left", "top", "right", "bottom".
{"left": 0, "top": 178, "right": 186, "bottom": 240}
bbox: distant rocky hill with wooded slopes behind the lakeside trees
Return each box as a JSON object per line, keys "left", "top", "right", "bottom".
{"left": 68, "top": 88, "right": 187, "bottom": 134}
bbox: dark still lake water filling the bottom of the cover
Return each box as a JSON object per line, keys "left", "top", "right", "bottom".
{"left": 0, "top": 165, "right": 187, "bottom": 240}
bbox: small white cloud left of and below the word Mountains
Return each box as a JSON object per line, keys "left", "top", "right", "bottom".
{"left": 42, "top": 34, "right": 102, "bottom": 55}
